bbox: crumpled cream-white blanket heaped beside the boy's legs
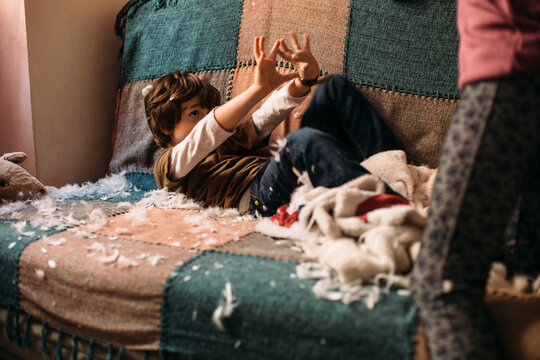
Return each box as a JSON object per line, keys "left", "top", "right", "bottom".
{"left": 257, "top": 151, "right": 435, "bottom": 283}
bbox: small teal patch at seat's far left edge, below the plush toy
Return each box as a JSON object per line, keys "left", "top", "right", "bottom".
{"left": 0, "top": 219, "right": 62, "bottom": 308}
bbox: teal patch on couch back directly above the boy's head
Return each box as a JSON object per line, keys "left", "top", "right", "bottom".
{"left": 121, "top": 0, "right": 243, "bottom": 84}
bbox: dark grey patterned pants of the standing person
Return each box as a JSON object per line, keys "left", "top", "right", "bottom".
{"left": 411, "top": 75, "right": 540, "bottom": 359}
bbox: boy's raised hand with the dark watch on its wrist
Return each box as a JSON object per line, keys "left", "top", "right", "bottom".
{"left": 278, "top": 31, "right": 320, "bottom": 80}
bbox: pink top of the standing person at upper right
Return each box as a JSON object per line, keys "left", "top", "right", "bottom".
{"left": 457, "top": 0, "right": 540, "bottom": 89}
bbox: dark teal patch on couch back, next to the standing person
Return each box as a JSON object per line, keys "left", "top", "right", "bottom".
{"left": 344, "top": 0, "right": 459, "bottom": 99}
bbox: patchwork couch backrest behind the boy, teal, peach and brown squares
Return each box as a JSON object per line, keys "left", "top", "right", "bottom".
{"left": 110, "top": 0, "right": 459, "bottom": 172}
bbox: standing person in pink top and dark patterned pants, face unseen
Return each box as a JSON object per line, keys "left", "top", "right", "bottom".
{"left": 411, "top": 0, "right": 540, "bottom": 359}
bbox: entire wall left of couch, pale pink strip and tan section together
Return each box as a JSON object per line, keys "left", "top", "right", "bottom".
{"left": 0, "top": 0, "right": 127, "bottom": 187}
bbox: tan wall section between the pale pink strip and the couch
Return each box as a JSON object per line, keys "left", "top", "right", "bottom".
{"left": 23, "top": 0, "right": 126, "bottom": 186}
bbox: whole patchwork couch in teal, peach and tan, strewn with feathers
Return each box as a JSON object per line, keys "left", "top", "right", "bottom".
{"left": 0, "top": 0, "right": 540, "bottom": 359}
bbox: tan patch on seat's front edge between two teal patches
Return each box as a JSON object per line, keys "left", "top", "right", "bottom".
{"left": 19, "top": 231, "right": 196, "bottom": 350}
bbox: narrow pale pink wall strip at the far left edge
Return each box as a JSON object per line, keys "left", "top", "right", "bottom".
{"left": 0, "top": 0, "right": 36, "bottom": 176}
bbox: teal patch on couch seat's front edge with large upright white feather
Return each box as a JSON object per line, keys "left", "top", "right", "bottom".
{"left": 161, "top": 251, "right": 417, "bottom": 360}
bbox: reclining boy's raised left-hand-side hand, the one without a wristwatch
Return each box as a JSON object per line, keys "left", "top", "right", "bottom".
{"left": 253, "top": 36, "right": 297, "bottom": 91}
